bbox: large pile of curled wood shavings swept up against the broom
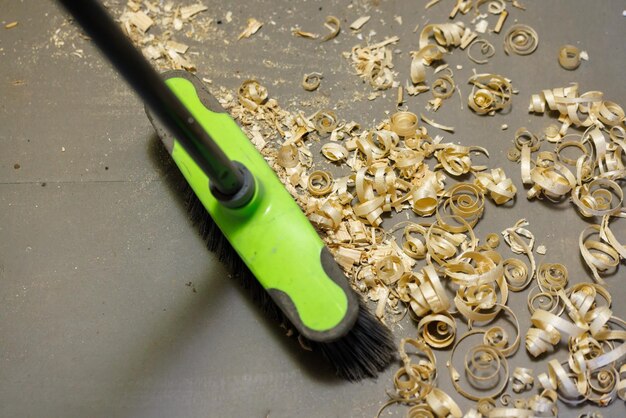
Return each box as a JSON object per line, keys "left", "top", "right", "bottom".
{"left": 220, "top": 68, "right": 626, "bottom": 417}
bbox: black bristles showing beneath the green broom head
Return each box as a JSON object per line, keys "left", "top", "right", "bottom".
{"left": 182, "top": 186, "right": 396, "bottom": 381}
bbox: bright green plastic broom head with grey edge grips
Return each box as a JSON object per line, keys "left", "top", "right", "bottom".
{"left": 148, "top": 71, "right": 359, "bottom": 342}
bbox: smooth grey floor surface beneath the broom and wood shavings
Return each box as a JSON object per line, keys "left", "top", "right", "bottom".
{"left": 0, "top": 0, "right": 626, "bottom": 418}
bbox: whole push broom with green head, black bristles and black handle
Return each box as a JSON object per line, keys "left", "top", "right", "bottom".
{"left": 60, "top": 0, "right": 395, "bottom": 380}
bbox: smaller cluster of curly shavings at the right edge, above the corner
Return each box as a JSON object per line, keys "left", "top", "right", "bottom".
{"left": 514, "top": 84, "right": 626, "bottom": 284}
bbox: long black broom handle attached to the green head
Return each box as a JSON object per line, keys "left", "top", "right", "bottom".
{"left": 59, "top": 0, "right": 244, "bottom": 196}
